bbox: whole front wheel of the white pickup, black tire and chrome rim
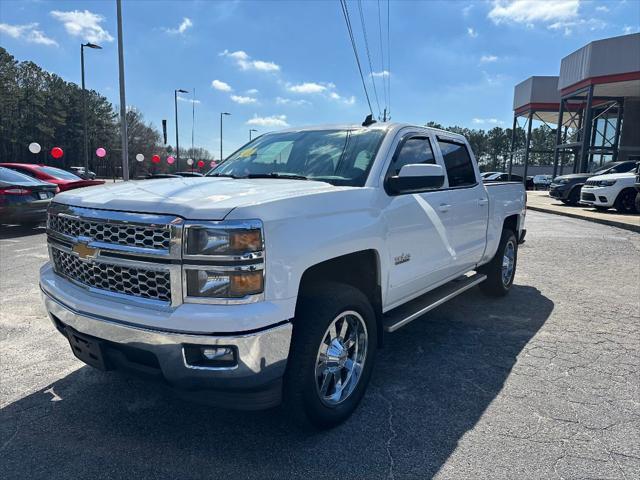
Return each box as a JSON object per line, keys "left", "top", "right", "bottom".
{"left": 284, "top": 284, "right": 378, "bottom": 429}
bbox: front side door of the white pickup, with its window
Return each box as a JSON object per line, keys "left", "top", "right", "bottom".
{"left": 383, "top": 132, "right": 453, "bottom": 307}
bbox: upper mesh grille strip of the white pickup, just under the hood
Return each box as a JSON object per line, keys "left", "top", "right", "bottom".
{"left": 48, "top": 213, "right": 171, "bottom": 251}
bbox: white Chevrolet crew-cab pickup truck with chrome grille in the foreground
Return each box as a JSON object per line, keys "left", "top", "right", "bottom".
{"left": 40, "top": 123, "right": 526, "bottom": 428}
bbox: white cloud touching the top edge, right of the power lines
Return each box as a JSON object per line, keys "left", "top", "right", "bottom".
{"left": 488, "top": 0, "right": 580, "bottom": 24}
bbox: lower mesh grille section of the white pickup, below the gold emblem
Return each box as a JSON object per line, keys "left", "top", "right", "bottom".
{"left": 51, "top": 246, "right": 172, "bottom": 303}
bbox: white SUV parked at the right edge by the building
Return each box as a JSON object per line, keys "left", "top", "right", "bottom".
{"left": 580, "top": 172, "right": 637, "bottom": 213}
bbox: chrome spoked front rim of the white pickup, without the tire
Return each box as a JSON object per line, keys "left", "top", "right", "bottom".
{"left": 315, "top": 310, "right": 369, "bottom": 407}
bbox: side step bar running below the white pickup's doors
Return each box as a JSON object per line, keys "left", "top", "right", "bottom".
{"left": 383, "top": 273, "right": 487, "bottom": 332}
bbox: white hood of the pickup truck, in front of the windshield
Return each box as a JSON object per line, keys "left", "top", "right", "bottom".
{"left": 54, "top": 177, "right": 341, "bottom": 220}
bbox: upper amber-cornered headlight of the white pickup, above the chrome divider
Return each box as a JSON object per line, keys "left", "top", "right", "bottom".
{"left": 184, "top": 223, "right": 263, "bottom": 256}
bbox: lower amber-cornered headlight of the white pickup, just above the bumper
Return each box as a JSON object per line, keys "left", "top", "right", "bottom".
{"left": 185, "top": 267, "right": 264, "bottom": 299}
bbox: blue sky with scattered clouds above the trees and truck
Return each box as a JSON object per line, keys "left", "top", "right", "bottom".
{"left": 0, "top": 0, "right": 640, "bottom": 157}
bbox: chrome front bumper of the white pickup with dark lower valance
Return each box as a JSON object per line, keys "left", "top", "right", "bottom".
{"left": 42, "top": 282, "right": 292, "bottom": 409}
